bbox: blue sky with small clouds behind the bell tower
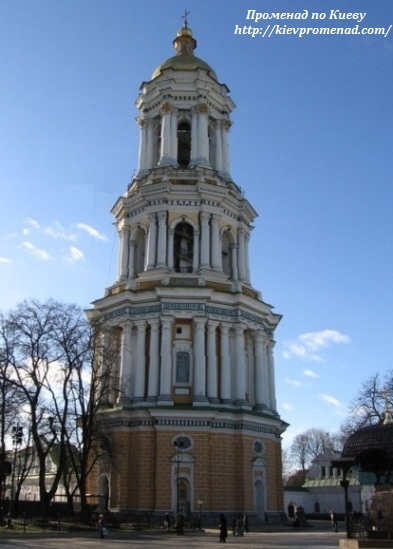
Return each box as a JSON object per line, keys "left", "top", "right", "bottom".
{"left": 0, "top": 0, "right": 393, "bottom": 445}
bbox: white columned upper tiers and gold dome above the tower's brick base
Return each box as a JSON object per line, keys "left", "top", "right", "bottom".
{"left": 95, "top": 23, "right": 281, "bottom": 415}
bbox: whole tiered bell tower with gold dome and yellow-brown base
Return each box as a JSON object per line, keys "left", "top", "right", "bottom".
{"left": 92, "top": 22, "right": 287, "bottom": 521}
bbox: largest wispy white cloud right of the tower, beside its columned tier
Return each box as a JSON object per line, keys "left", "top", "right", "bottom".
{"left": 283, "top": 330, "right": 351, "bottom": 362}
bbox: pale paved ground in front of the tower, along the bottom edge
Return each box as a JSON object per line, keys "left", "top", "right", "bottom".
{"left": 0, "top": 528, "right": 345, "bottom": 549}
